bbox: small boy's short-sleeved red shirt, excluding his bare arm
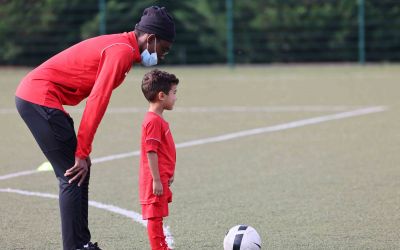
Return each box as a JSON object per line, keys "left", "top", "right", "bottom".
{"left": 139, "top": 112, "right": 176, "bottom": 205}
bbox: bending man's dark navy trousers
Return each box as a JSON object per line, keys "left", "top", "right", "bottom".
{"left": 16, "top": 97, "right": 90, "bottom": 250}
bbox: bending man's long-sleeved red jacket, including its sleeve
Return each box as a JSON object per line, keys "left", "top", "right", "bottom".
{"left": 16, "top": 32, "right": 141, "bottom": 158}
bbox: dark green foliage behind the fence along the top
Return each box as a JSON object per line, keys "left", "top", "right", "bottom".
{"left": 0, "top": 0, "right": 400, "bottom": 65}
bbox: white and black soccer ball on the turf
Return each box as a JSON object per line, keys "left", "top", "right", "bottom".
{"left": 224, "top": 225, "right": 261, "bottom": 250}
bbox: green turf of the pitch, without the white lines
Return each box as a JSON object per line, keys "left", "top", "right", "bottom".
{"left": 0, "top": 65, "right": 400, "bottom": 250}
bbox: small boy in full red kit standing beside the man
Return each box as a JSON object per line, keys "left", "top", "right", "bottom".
{"left": 139, "top": 69, "right": 179, "bottom": 250}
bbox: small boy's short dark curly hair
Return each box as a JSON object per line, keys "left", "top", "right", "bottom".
{"left": 142, "top": 69, "right": 179, "bottom": 102}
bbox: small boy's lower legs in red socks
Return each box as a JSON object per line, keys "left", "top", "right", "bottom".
{"left": 147, "top": 217, "right": 168, "bottom": 250}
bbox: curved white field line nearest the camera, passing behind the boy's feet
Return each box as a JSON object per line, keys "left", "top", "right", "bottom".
{"left": 0, "top": 188, "right": 173, "bottom": 248}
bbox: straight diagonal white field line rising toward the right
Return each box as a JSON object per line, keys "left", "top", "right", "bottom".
{"left": 0, "top": 106, "right": 387, "bottom": 180}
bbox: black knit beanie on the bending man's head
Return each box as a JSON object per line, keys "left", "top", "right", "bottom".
{"left": 135, "top": 6, "right": 175, "bottom": 42}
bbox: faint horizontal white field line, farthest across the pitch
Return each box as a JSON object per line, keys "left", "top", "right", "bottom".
{"left": 0, "top": 105, "right": 361, "bottom": 115}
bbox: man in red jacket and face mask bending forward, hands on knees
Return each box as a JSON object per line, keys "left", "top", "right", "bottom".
{"left": 16, "top": 6, "right": 175, "bottom": 250}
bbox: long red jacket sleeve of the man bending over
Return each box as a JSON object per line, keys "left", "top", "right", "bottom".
{"left": 75, "top": 44, "right": 134, "bottom": 159}
